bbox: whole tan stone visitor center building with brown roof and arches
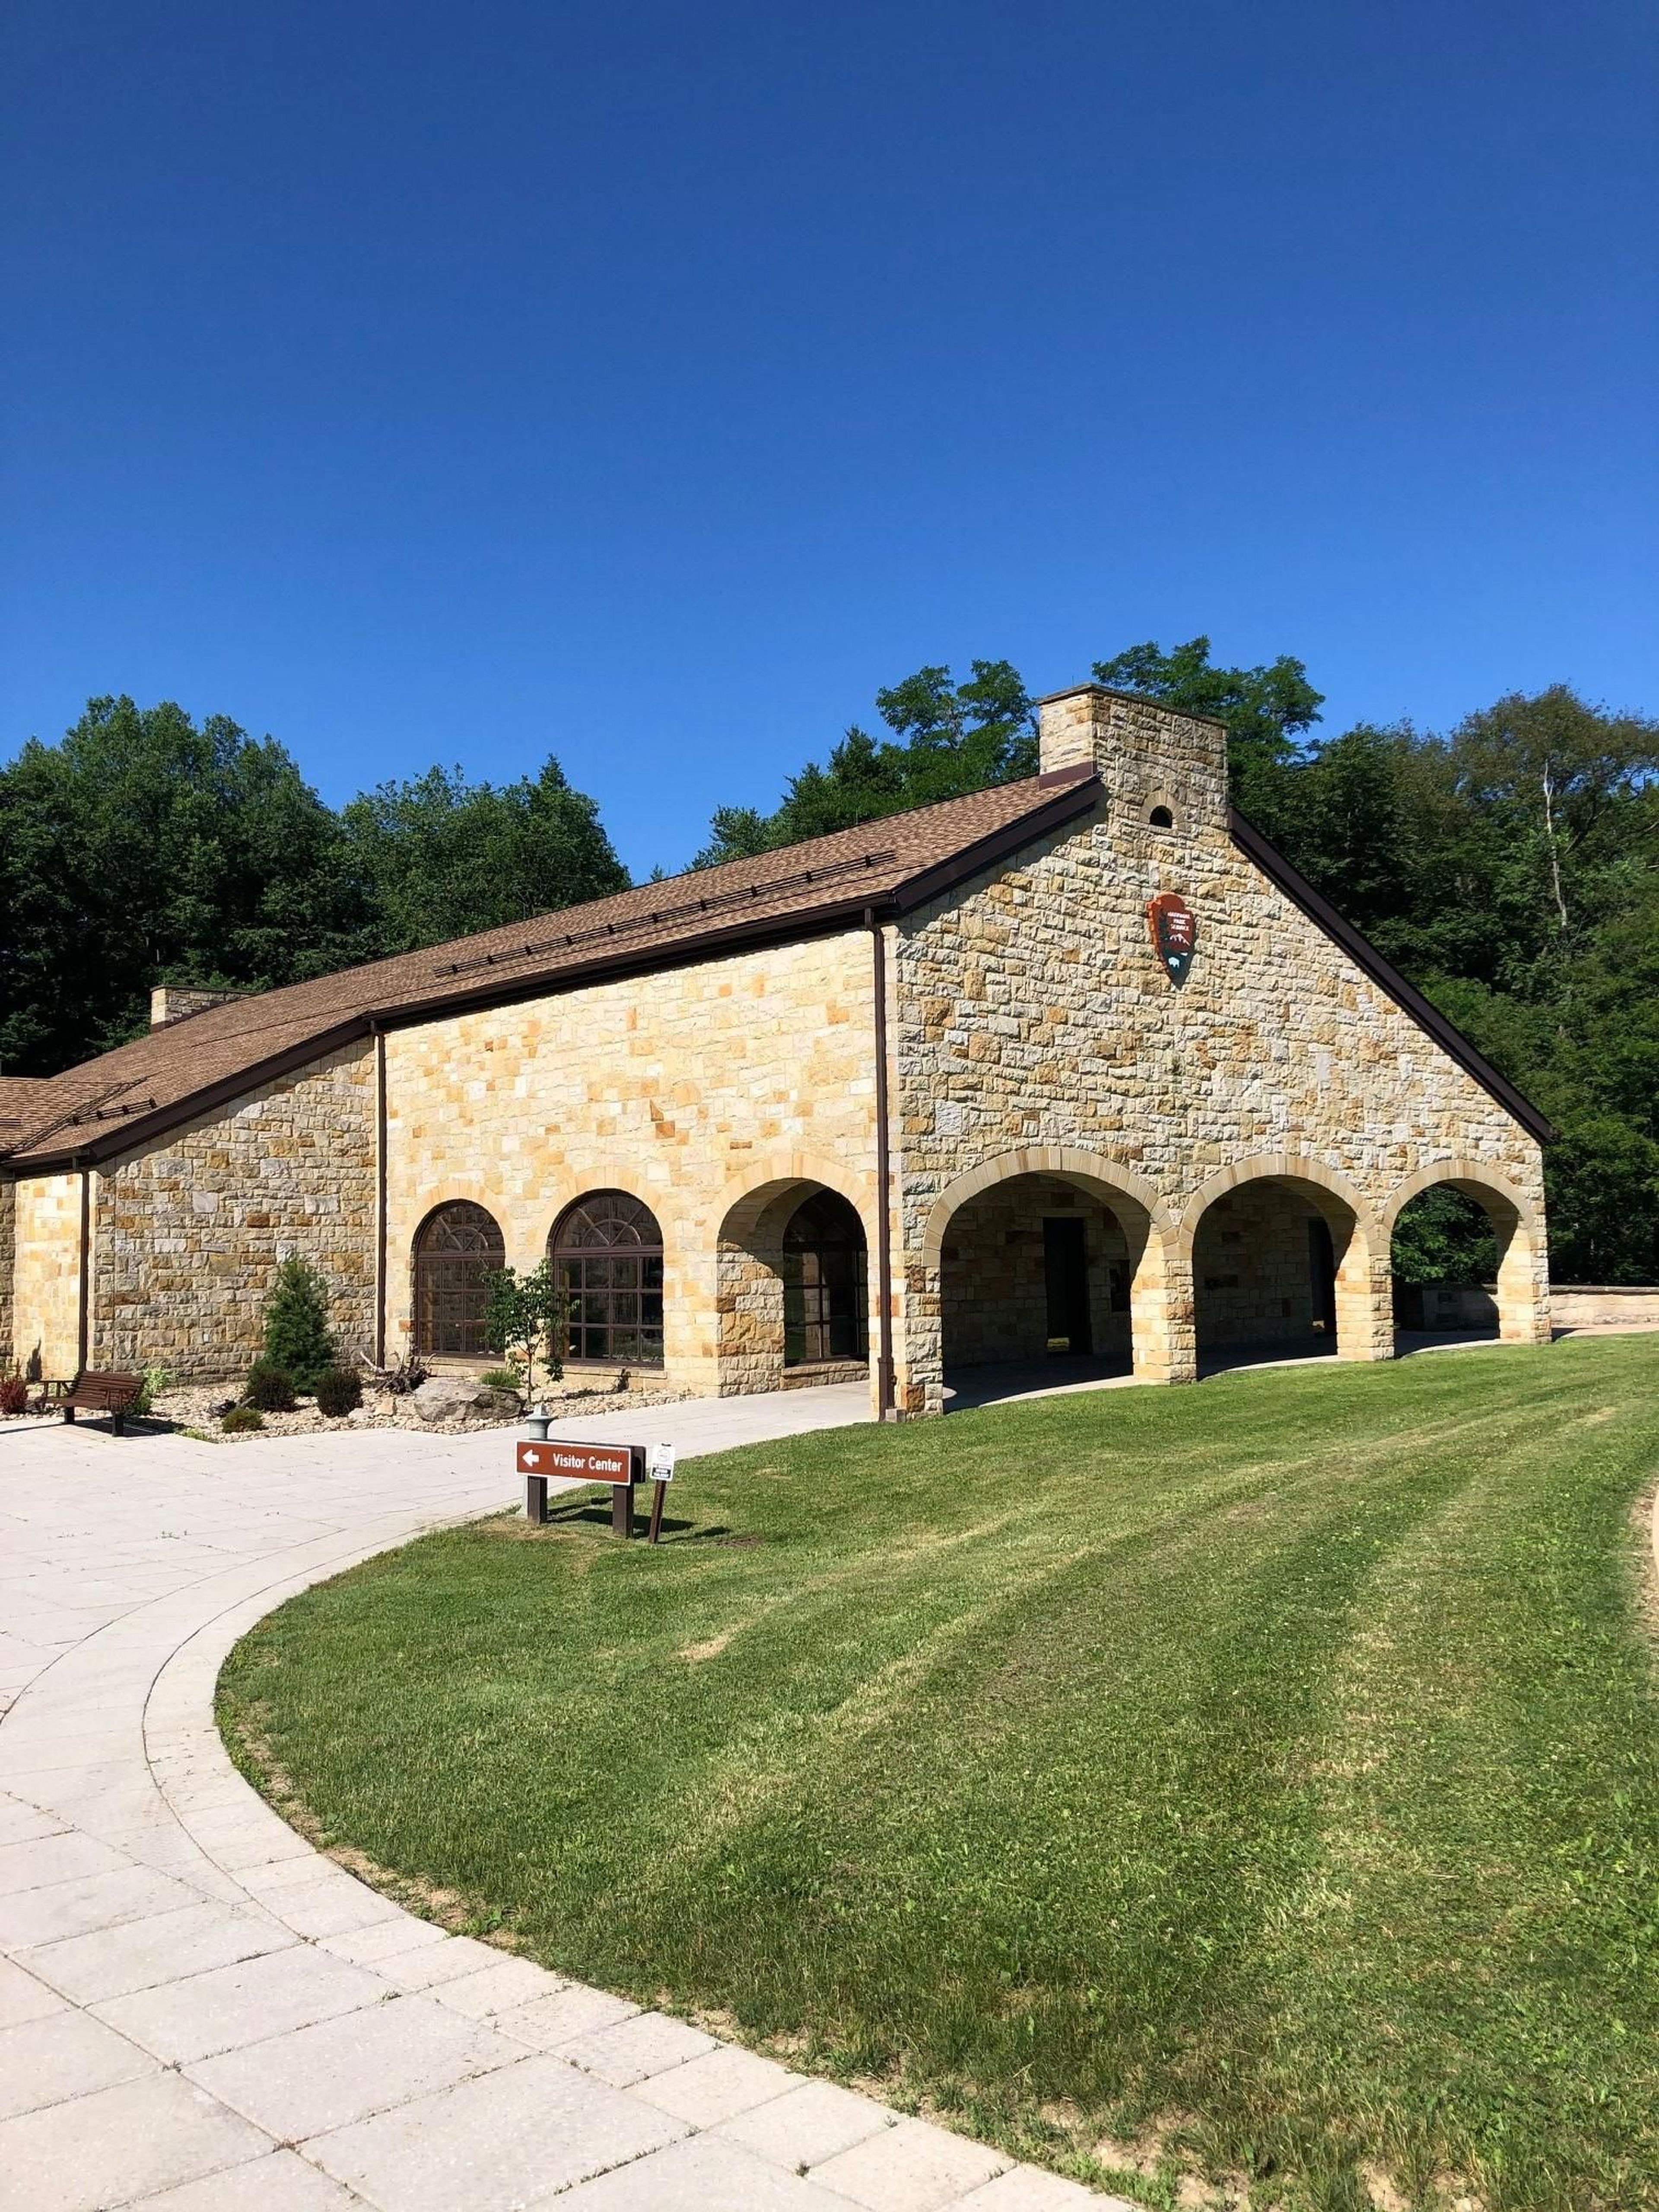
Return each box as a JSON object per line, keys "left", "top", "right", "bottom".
{"left": 0, "top": 686, "right": 1548, "bottom": 1414}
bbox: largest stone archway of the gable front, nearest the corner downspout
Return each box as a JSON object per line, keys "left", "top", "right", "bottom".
{"left": 905, "top": 1146, "right": 1192, "bottom": 1411}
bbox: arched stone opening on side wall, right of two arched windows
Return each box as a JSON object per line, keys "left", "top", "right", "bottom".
{"left": 715, "top": 1155, "right": 878, "bottom": 1398}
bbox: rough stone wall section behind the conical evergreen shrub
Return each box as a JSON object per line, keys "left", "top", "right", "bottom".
{"left": 93, "top": 1044, "right": 376, "bottom": 1380}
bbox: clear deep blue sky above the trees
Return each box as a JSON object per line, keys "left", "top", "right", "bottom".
{"left": 0, "top": 0, "right": 1659, "bottom": 871}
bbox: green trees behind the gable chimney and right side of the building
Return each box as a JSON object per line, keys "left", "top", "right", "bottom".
{"left": 697, "top": 637, "right": 1659, "bottom": 1283}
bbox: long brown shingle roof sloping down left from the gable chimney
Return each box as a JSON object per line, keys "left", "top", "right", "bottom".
{"left": 0, "top": 770, "right": 1119, "bottom": 1170}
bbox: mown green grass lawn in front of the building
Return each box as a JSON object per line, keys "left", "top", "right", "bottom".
{"left": 221, "top": 1336, "right": 1659, "bottom": 2212}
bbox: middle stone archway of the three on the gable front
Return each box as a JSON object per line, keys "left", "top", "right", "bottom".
{"left": 1181, "top": 1153, "right": 1394, "bottom": 1363}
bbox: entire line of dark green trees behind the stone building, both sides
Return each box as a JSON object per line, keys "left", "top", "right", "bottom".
{"left": 0, "top": 637, "right": 1659, "bottom": 1283}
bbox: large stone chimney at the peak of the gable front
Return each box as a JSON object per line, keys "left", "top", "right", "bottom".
{"left": 1037, "top": 683, "right": 1228, "bottom": 832}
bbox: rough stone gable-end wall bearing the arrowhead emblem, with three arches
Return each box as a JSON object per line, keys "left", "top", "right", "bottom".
{"left": 891, "top": 712, "right": 1548, "bottom": 1411}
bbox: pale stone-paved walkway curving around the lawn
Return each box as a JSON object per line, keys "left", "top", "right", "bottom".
{"left": 0, "top": 1382, "right": 1110, "bottom": 2212}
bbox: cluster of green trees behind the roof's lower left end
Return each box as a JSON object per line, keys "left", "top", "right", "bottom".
{"left": 0, "top": 699, "right": 628, "bottom": 1075}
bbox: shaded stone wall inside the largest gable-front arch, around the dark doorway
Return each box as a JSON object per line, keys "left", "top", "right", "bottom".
{"left": 940, "top": 1175, "right": 1128, "bottom": 1367}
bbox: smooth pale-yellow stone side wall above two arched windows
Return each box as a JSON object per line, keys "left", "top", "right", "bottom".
{"left": 385, "top": 929, "right": 876, "bottom": 1391}
